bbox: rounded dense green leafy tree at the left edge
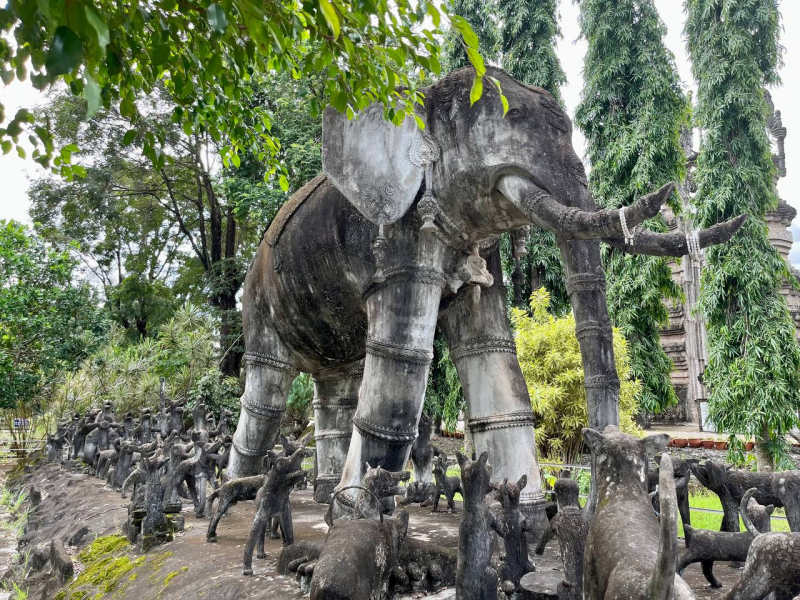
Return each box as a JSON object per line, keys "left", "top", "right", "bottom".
{"left": 0, "top": 220, "right": 103, "bottom": 408}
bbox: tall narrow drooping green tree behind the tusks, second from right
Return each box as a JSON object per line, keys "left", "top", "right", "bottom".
{"left": 576, "top": 0, "right": 687, "bottom": 412}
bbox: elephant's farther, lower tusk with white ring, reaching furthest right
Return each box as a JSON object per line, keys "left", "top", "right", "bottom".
{"left": 603, "top": 215, "right": 747, "bottom": 256}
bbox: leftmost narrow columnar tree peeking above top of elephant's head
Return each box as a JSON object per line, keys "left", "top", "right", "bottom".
{"left": 442, "top": 0, "right": 499, "bottom": 73}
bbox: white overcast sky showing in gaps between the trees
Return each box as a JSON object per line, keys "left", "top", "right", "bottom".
{"left": 0, "top": 0, "right": 800, "bottom": 264}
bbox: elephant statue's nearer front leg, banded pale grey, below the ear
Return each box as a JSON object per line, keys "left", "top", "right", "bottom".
{"left": 339, "top": 268, "right": 445, "bottom": 488}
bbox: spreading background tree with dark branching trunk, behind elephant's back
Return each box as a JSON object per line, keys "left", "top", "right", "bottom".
{"left": 31, "top": 73, "right": 323, "bottom": 375}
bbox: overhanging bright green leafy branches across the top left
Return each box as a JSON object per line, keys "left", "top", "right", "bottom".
{"left": 0, "top": 0, "right": 485, "bottom": 180}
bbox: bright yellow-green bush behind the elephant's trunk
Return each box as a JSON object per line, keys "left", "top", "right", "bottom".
{"left": 511, "top": 288, "right": 642, "bottom": 464}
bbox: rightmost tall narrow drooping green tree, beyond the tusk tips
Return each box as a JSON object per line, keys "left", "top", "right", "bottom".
{"left": 685, "top": 0, "right": 800, "bottom": 468}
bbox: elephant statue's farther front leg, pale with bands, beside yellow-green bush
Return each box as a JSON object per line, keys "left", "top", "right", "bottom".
{"left": 439, "top": 247, "right": 548, "bottom": 537}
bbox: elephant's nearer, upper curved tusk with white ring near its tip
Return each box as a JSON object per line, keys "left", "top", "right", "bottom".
{"left": 496, "top": 175, "right": 675, "bottom": 240}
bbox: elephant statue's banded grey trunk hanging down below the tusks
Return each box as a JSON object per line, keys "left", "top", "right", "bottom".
{"left": 558, "top": 239, "right": 619, "bottom": 517}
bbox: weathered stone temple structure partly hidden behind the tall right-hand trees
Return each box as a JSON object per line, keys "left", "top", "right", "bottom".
{"left": 655, "top": 90, "right": 800, "bottom": 426}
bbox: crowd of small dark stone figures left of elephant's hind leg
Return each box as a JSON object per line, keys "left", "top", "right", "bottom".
{"left": 45, "top": 400, "right": 232, "bottom": 550}
